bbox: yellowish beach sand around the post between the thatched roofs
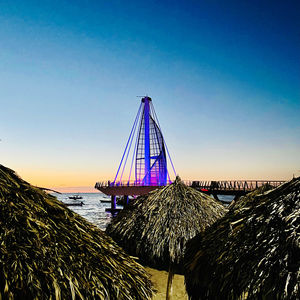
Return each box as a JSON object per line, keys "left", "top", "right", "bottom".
{"left": 146, "top": 267, "right": 188, "bottom": 300}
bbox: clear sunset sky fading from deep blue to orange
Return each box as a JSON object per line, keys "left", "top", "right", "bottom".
{"left": 0, "top": 0, "right": 300, "bottom": 191}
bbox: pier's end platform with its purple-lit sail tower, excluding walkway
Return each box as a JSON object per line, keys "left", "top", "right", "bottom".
{"left": 95, "top": 96, "right": 176, "bottom": 213}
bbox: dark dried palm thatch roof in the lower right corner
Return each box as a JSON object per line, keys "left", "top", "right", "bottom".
{"left": 185, "top": 178, "right": 300, "bottom": 300}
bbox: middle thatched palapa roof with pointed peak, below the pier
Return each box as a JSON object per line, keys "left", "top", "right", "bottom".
{"left": 106, "top": 177, "right": 226, "bottom": 269}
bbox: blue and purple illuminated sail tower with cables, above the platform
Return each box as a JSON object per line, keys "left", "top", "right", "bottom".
{"left": 112, "top": 96, "right": 176, "bottom": 186}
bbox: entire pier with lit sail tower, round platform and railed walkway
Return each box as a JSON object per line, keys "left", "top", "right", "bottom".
{"left": 95, "top": 96, "right": 285, "bottom": 214}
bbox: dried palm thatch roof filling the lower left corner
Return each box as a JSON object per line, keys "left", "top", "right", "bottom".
{"left": 0, "top": 165, "right": 152, "bottom": 300}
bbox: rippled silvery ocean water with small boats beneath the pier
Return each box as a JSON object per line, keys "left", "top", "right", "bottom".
{"left": 52, "top": 192, "right": 233, "bottom": 230}
